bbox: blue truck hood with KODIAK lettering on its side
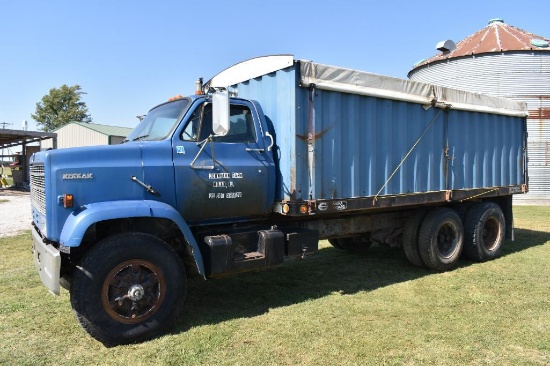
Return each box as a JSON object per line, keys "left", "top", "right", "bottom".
{"left": 31, "top": 141, "right": 175, "bottom": 240}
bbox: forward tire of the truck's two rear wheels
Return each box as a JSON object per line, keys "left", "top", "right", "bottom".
{"left": 418, "top": 207, "right": 464, "bottom": 271}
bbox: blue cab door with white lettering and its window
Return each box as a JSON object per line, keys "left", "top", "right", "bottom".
{"left": 173, "top": 101, "right": 275, "bottom": 224}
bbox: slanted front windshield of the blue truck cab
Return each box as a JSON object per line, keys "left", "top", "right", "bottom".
{"left": 124, "top": 99, "right": 189, "bottom": 142}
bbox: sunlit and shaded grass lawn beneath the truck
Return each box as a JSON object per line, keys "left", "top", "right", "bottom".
{"left": 0, "top": 206, "right": 550, "bottom": 365}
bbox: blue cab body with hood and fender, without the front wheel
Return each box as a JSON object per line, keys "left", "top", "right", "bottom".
{"left": 31, "top": 94, "right": 284, "bottom": 278}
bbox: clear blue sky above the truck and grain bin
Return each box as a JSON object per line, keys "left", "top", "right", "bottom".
{"left": 0, "top": 0, "right": 550, "bottom": 130}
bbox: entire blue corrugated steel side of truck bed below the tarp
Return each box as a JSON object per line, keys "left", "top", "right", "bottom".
{"left": 314, "top": 91, "right": 525, "bottom": 199}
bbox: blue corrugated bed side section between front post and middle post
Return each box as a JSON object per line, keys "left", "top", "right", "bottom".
{"left": 314, "top": 91, "right": 445, "bottom": 199}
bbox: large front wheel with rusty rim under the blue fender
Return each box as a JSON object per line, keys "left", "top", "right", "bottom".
{"left": 71, "top": 233, "right": 187, "bottom": 345}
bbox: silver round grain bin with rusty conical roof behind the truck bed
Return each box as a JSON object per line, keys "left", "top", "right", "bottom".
{"left": 408, "top": 19, "right": 550, "bottom": 203}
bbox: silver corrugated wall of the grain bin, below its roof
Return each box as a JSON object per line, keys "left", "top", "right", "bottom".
{"left": 409, "top": 51, "right": 550, "bottom": 201}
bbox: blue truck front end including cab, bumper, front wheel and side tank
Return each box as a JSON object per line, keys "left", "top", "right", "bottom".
{"left": 31, "top": 89, "right": 302, "bottom": 342}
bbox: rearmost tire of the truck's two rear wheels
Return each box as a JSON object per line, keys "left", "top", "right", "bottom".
{"left": 464, "top": 202, "right": 506, "bottom": 262}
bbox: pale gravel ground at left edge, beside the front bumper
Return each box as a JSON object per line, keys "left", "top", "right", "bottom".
{"left": 0, "top": 189, "right": 32, "bottom": 238}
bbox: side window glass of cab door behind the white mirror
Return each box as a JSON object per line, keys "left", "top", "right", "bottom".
{"left": 181, "top": 103, "right": 256, "bottom": 143}
